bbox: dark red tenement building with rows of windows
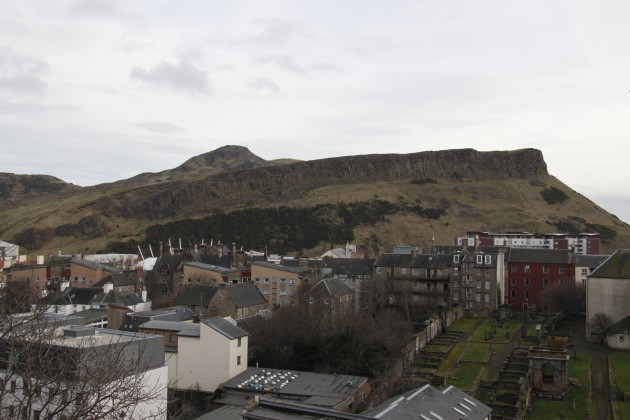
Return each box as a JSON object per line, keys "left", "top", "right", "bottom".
{"left": 506, "top": 248, "right": 575, "bottom": 312}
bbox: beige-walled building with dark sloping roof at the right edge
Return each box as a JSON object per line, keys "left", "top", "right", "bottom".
{"left": 586, "top": 249, "right": 630, "bottom": 342}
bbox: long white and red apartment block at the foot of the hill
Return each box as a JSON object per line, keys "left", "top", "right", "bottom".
{"left": 455, "top": 232, "right": 600, "bottom": 255}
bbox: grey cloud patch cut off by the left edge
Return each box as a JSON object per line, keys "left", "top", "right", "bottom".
{"left": 0, "top": 48, "right": 49, "bottom": 95}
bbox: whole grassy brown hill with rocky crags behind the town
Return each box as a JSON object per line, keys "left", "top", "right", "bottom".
{"left": 0, "top": 146, "right": 630, "bottom": 255}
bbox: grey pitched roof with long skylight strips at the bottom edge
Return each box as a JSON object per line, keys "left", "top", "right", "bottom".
{"left": 364, "top": 384, "right": 492, "bottom": 420}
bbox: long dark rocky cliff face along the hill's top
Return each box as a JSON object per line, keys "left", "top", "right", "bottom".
{"left": 92, "top": 149, "right": 547, "bottom": 218}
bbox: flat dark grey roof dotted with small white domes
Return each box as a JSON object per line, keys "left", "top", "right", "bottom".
{"left": 224, "top": 367, "right": 367, "bottom": 407}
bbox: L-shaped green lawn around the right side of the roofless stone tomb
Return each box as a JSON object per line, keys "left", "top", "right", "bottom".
{"left": 529, "top": 353, "right": 590, "bottom": 420}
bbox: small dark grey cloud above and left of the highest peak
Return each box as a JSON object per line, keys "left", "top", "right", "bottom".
{"left": 130, "top": 61, "right": 211, "bottom": 95}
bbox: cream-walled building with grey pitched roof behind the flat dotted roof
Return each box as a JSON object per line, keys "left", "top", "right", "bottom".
{"left": 139, "top": 317, "right": 249, "bottom": 392}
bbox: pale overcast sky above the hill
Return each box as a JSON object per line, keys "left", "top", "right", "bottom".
{"left": 0, "top": 0, "right": 630, "bottom": 222}
